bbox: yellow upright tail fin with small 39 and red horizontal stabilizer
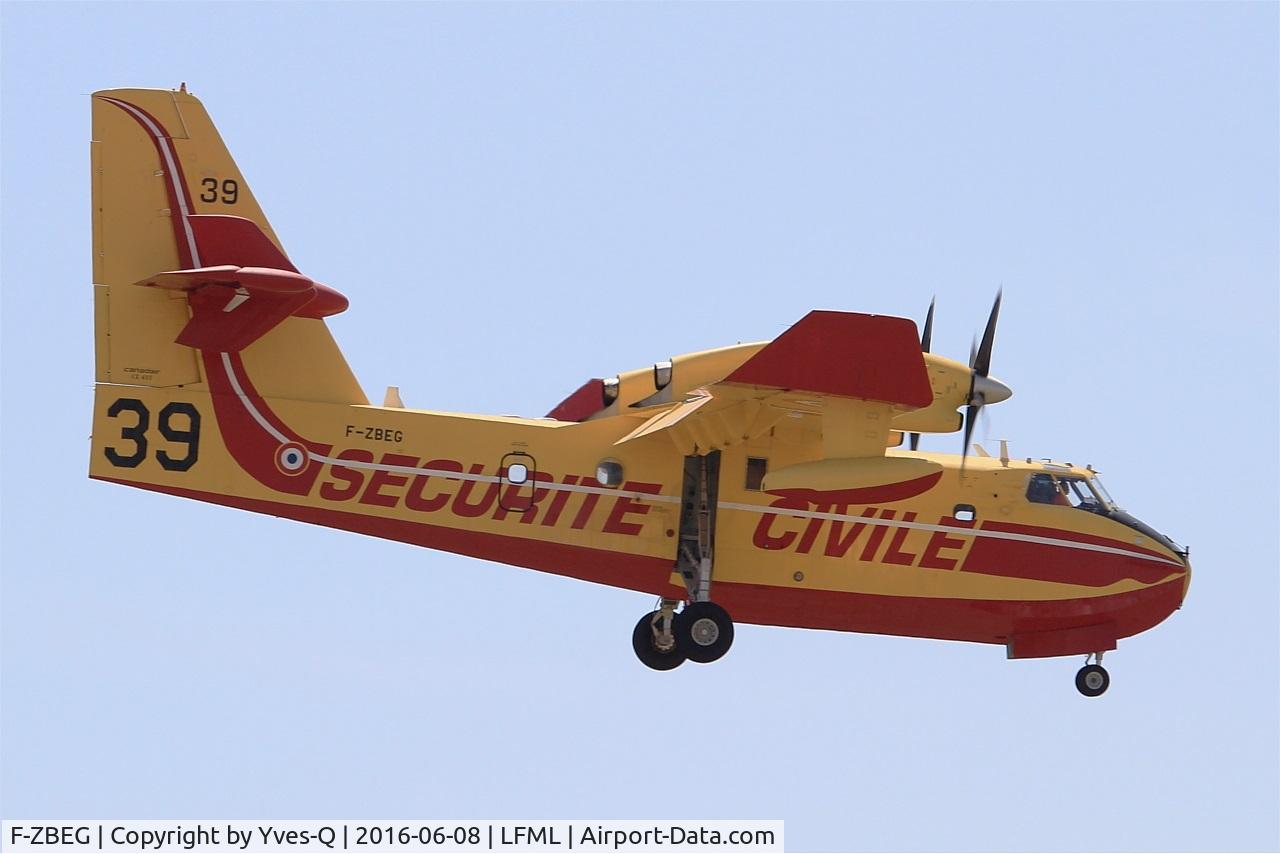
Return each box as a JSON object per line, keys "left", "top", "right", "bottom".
{"left": 92, "top": 90, "right": 369, "bottom": 403}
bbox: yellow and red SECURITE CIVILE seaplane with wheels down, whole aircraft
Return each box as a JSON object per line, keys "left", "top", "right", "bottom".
{"left": 90, "top": 87, "right": 1190, "bottom": 697}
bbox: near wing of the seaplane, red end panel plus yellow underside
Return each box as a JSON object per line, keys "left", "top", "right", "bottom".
{"left": 617, "top": 311, "right": 933, "bottom": 458}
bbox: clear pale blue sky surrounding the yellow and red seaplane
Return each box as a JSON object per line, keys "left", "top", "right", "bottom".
{"left": 0, "top": 3, "right": 1280, "bottom": 850}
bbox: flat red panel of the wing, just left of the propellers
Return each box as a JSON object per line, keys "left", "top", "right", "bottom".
{"left": 726, "top": 311, "right": 933, "bottom": 408}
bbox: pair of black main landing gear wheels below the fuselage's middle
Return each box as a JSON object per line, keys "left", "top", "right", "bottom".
{"left": 631, "top": 599, "right": 733, "bottom": 670}
